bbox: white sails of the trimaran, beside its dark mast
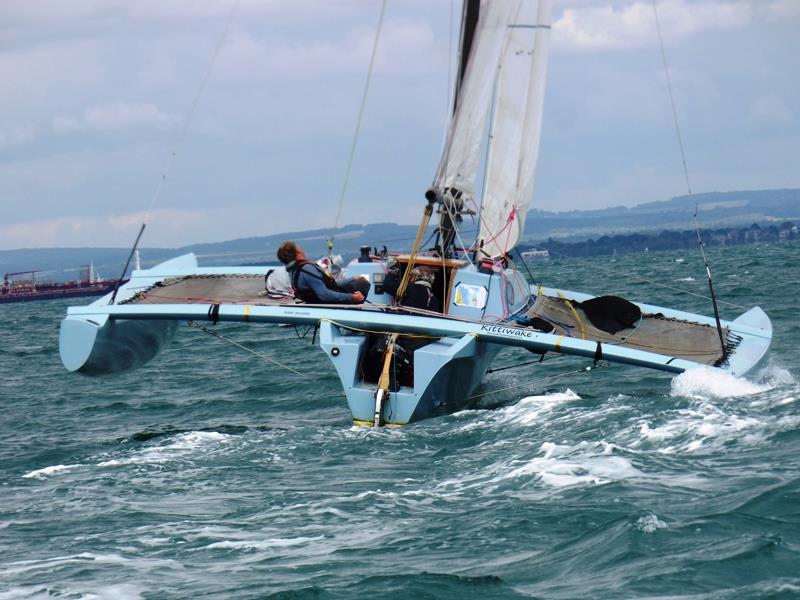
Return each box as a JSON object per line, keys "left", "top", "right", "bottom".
{"left": 432, "top": 0, "right": 549, "bottom": 255}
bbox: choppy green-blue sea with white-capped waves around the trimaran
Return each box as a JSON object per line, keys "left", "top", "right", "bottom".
{"left": 0, "top": 242, "right": 800, "bottom": 600}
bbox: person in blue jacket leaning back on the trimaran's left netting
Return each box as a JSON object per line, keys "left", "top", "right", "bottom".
{"left": 278, "top": 241, "right": 370, "bottom": 304}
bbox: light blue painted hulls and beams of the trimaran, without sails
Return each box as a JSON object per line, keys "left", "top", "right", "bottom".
{"left": 59, "top": 255, "right": 772, "bottom": 425}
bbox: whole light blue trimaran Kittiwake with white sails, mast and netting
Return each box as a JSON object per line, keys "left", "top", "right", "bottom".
{"left": 60, "top": 0, "right": 772, "bottom": 426}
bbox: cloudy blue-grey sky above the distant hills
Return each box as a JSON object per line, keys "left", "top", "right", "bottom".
{"left": 0, "top": 0, "right": 800, "bottom": 250}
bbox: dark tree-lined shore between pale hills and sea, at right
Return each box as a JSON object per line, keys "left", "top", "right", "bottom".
{"left": 519, "top": 221, "right": 800, "bottom": 257}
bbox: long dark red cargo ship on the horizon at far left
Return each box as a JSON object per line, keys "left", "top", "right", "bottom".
{"left": 0, "top": 265, "right": 124, "bottom": 304}
